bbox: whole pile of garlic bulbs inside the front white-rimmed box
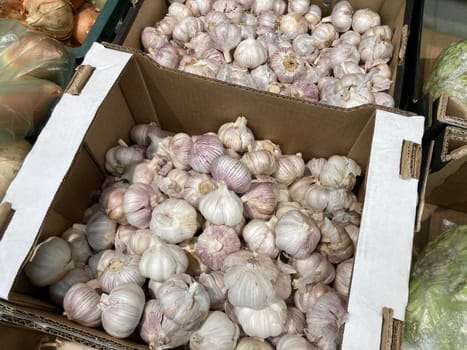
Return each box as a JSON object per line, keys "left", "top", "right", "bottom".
{"left": 25, "top": 117, "right": 361, "bottom": 350}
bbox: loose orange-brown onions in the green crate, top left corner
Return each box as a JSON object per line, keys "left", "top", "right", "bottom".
{"left": 0, "top": 0, "right": 107, "bottom": 46}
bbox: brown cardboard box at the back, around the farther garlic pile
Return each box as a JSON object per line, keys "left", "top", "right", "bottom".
{"left": 123, "top": 0, "right": 417, "bottom": 106}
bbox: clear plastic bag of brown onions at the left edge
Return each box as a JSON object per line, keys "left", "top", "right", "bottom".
{"left": 0, "top": 19, "right": 75, "bottom": 144}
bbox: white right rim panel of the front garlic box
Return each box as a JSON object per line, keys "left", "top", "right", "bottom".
{"left": 342, "top": 110, "right": 424, "bottom": 350}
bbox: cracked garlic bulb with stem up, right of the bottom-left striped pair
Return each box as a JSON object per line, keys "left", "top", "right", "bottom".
{"left": 157, "top": 274, "right": 209, "bottom": 330}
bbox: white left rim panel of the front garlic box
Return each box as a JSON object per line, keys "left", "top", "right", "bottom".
{"left": 0, "top": 44, "right": 131, "bottom": 299}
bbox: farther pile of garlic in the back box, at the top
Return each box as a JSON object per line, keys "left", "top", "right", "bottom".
{"left": 141, "top": 0, "right": 394, "bottom": 108}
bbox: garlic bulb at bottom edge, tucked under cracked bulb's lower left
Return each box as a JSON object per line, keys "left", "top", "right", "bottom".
{"left": 139, "top": 299, "right": 190, "bottom": 349}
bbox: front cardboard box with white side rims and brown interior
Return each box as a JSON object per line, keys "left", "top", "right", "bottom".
{"left": 0, "top": 44, "right": 424, "bottom": 350}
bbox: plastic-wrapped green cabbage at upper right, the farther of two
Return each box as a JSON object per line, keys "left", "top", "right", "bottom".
{"left": 424, "top": 40, "right": 467, "bottom": 104}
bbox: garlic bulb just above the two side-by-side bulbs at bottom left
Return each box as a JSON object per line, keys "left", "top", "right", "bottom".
{"left": 99, "top": 254, "right": 146, "bottom": 293}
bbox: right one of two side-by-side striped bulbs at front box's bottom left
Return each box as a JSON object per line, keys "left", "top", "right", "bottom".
{"left": 97, "top": 283, "right": 145, "bottom": 338}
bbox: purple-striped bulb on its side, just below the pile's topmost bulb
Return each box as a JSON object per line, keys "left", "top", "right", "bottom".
{"left": 210, "top": 155, "right": 251, "bottom": 193}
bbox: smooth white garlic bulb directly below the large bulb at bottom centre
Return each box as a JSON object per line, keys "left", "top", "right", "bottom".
{"left": 234, "top": 298, "right": 287, "bottom": 338}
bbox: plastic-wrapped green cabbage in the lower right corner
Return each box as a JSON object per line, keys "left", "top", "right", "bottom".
{"left": 402, "top": 225, "right": 467, "bottom": 350}
